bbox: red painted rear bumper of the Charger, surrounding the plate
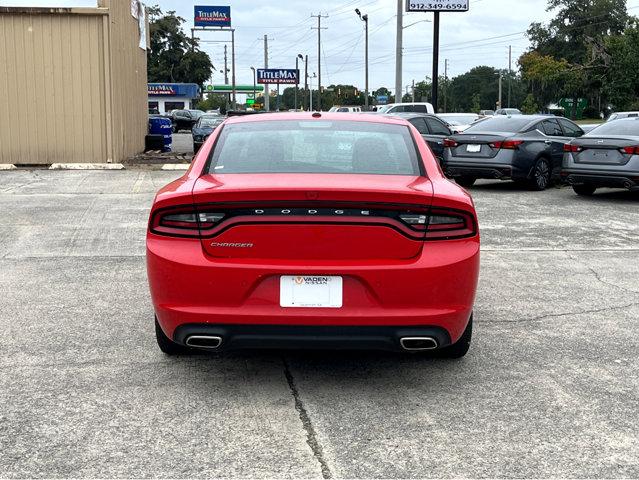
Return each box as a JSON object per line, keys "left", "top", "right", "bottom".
{"left": 147, "top": 234, "right": 479, "bottom": 342}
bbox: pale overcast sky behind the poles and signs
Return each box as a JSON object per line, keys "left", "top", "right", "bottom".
{"left": 7, "top": 0, "right": 639, "bottom": 95}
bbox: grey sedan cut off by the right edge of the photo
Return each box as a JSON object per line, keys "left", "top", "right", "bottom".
{"left": 561, "top": 117, "right": 639, "bottom": 195}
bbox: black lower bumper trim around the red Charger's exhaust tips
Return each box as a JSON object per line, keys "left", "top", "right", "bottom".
{"left": 173, "top": 324, "right": 451, "bottom": 352}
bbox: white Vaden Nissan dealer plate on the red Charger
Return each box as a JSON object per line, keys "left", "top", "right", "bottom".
{"left": 280, "top": 275, "right": 342, "bottom": 308}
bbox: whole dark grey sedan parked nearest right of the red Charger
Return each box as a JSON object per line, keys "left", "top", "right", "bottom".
{"left": 444, "top": 115, "right": 584, "bottom": 190}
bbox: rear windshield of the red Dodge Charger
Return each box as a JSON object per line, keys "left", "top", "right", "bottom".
{"left": 210, "top": 119, "right": 420, "bottom": 175}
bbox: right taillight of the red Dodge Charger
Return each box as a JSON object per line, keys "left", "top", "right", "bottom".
{"left": 400, "top": 208, "right": 477, "bottom": 240}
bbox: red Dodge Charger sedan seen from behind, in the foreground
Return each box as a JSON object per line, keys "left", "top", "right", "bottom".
{"left": 146, "top": 113, "right": 479, "bottom": 358}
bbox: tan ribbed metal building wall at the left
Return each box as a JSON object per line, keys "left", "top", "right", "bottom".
{"left": 0, "top": 0, "right": 148, "bottom": 164}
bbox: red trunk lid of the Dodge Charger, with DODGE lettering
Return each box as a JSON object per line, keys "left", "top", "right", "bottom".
{"left": 193, "top": 174, "right": 432, "bottom": 261}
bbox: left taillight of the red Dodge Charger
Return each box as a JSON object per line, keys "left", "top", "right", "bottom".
{"left": 151, "top": 207, "right": 224, "bottom": 237}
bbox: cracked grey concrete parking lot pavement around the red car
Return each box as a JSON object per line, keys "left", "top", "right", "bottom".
{"left": 0, "top": 170, "right": 639, "bottom": 478}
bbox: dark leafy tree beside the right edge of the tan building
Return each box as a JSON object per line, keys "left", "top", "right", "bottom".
{"left": 147, "top": 6, "right": 213, "bottom": 86}
